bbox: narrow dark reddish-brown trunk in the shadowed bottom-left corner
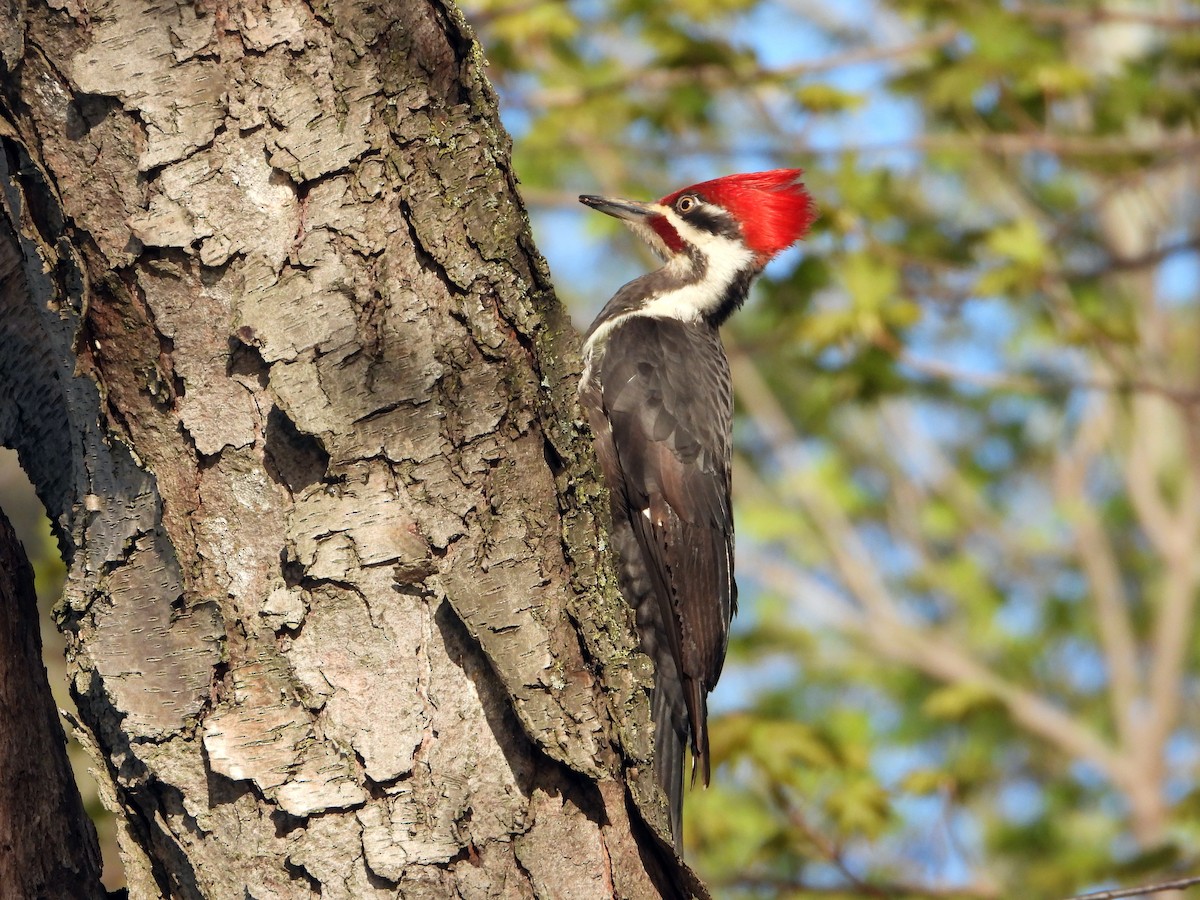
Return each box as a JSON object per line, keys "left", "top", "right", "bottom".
{"left": 0, "top": 504, "right": 104, "bottom": 900}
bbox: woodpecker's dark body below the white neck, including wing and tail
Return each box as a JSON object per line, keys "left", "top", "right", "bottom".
{"left": 580, "top": 316, "right": 736, "bottom": 842}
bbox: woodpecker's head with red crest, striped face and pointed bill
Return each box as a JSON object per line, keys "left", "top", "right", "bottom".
{"left": 580, "top": 169, "right": 816, "bottom": 269}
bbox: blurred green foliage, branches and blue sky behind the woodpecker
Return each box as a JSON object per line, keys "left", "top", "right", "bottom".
{"left": 463, "top": 0, "right": 1200, "bottom": 898}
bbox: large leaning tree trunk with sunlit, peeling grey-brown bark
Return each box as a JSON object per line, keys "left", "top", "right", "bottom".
{"left": 0, "top": 0, "right": 702, "bottom": 900}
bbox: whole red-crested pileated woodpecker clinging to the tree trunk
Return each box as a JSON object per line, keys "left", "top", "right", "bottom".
{"left": 580, "top": 169, "right": 815, "bottom": 847}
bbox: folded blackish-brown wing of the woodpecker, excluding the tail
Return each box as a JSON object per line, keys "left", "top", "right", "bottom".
{"left": 599, "top": 316, "right": 737, "bottom": 784}
